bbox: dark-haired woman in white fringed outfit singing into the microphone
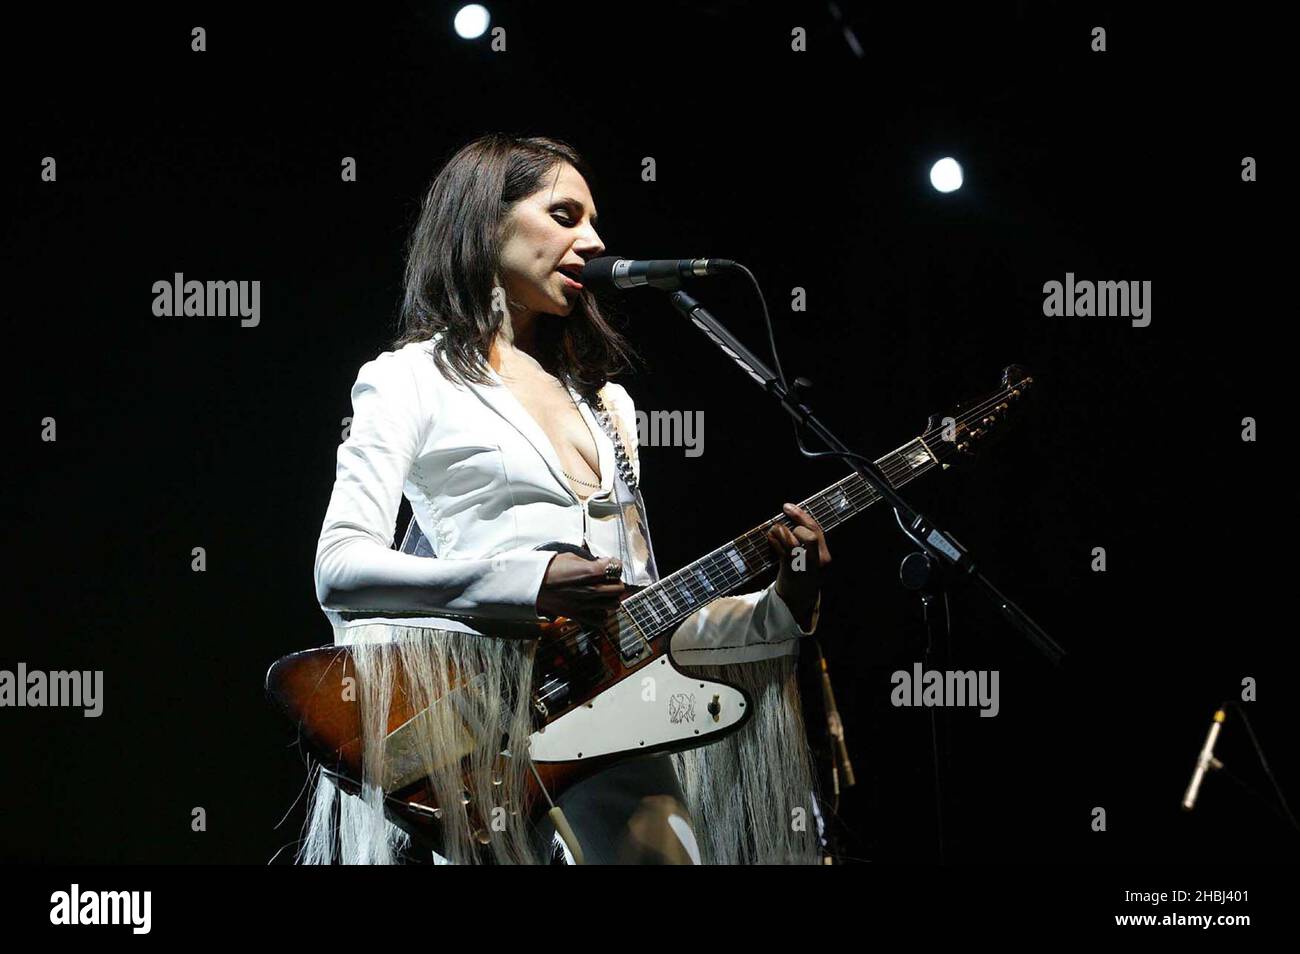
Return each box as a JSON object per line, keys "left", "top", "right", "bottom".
{"left": 299, "top": 135, "right": 829, "bottom": 863}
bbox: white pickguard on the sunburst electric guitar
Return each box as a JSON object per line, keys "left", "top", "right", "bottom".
{"left": 529, "top": 656, "right": 746, "bottom": 762}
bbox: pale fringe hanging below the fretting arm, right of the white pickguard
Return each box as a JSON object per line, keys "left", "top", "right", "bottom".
{"left": 673, "top": 655, "right": 820, "bottom": 864}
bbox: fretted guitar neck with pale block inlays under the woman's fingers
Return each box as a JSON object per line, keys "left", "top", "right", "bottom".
{"left": 623, "top": 438, "right": 939, "bottom": 638}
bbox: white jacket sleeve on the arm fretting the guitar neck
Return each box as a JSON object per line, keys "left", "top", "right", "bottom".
{"left": 605, "top": 383, "right": 822, "bottom": 665}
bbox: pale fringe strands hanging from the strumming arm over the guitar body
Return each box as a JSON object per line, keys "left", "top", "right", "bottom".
{"left": 296, "top": 623, "right": 543, "bottom": 864}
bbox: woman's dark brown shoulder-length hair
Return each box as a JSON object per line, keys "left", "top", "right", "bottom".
{"left": 394, "top": 133, "right": 634, "bottom": 400}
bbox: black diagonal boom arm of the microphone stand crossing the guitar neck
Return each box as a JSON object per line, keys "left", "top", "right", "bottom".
{"left": 668, "top": 291, "right": 1065, "bottom": 667}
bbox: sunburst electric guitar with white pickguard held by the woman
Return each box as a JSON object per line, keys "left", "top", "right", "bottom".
{"left": 267, "top": 365, "right": 1034, "bottom": 850}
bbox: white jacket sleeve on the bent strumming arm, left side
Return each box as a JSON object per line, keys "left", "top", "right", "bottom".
{"left": 315, "top": 352, "right": 555, "bottom": 620}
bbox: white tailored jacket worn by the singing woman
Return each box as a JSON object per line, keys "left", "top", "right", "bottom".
{"left": 315, "top": 338, "right": 822, "bottom": 664}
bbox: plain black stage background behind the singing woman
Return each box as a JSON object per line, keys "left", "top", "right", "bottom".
{"left": 0, "top": 3, "right": 1297, "bottom": 863}
